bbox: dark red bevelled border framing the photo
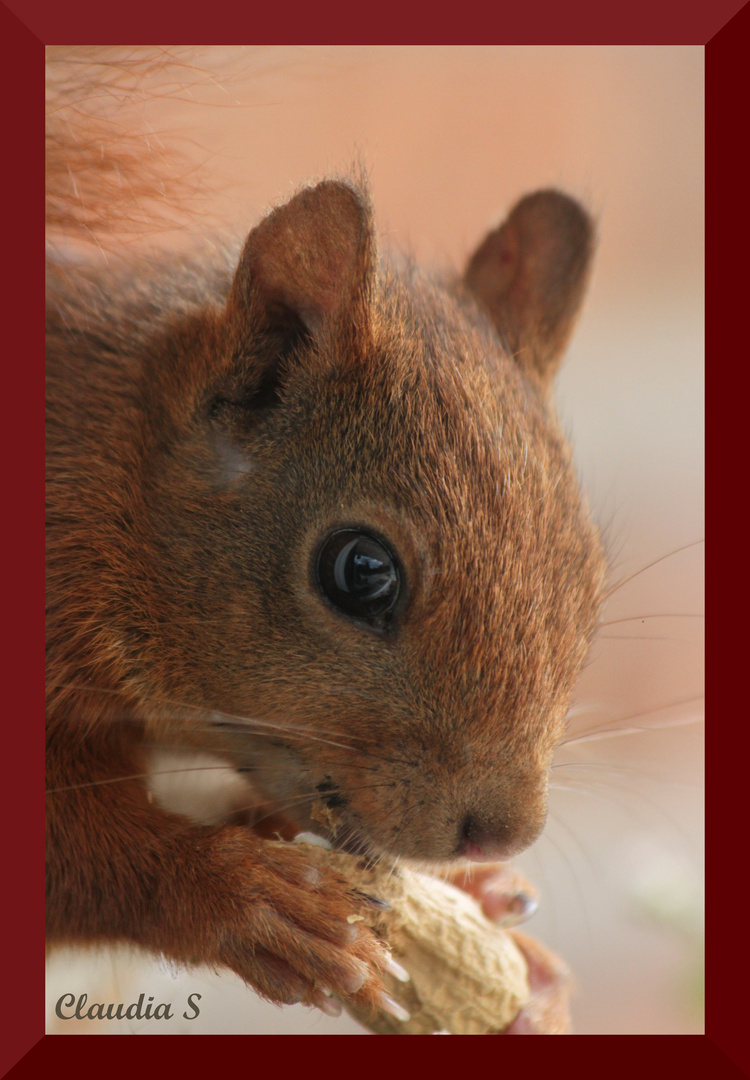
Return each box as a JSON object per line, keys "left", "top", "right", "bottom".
{"left": 0, "top": 0, "right": 734, "bottom": 1080}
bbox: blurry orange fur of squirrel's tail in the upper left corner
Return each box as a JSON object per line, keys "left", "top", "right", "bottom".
{"left": 45, "top": 46, "right": 204, "bottom": 246}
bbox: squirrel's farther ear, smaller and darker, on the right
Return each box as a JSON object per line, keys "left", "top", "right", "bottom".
{"left": 465, "top": 191, "right": 593, "bottom": 381}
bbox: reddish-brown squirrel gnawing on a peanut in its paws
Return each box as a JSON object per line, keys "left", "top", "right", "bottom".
{"left": 46, "top": 50, "right": 605, "bottom": 1034}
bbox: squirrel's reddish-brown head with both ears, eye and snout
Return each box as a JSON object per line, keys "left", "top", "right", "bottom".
{"left": 142, "top": 181, "right": 603, "bottom": 860}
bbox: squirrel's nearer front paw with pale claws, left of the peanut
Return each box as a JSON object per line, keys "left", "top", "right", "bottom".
{"left": 211, "top": 841, "right": 388, "bottom": 1015}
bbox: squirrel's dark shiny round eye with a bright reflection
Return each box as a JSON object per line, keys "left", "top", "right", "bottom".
{"left": 317, "top": 529, "right": 401, "bottom": 629}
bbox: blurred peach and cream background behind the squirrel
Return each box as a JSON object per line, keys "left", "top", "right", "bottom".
{"left": 49, "top": 45, "right": 704, "bottom": 1035}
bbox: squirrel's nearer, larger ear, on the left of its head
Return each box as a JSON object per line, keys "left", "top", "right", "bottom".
{"left": 228, "top": 180, "right": 375, "bottom": 348}
